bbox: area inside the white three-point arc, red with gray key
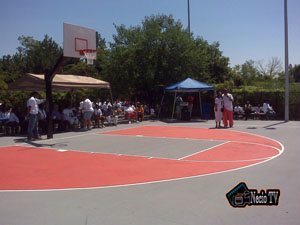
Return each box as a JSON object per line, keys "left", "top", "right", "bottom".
{"left": 0, "top": 125, "right": 284, "bottom": 191}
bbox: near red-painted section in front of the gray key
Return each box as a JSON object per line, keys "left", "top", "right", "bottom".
{"left": 0, "top": 146, "right": 261, "bottom": 190}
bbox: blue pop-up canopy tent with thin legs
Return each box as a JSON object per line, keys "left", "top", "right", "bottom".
{"left": 161, "top": 78, "right": 215, "bottom": 119}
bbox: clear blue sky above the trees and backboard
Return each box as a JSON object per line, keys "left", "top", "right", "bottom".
{"left": 0, "top": 0, "right": 300, "bottom": 68}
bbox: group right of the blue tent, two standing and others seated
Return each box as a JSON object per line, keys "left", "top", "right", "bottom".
{"left": 214, "top": 89, "right": 276, "bottom": 128}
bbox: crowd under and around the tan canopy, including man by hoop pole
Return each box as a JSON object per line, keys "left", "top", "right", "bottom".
{"left": 0, "top": 92, "right": 155, "bottom": 141}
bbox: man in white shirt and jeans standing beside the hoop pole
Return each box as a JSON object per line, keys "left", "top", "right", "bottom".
{"left": 27, "top": 91, "right": 44, "bottom": 141}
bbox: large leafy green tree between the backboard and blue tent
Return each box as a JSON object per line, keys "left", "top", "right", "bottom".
{"left": 105, "top": 15, "right": 230, "bottom": 101}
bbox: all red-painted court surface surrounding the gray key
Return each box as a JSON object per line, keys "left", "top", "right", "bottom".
{"left": 0, "top": 126, "right": 283, "bottom": 190}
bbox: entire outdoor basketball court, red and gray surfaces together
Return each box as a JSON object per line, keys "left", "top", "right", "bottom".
{"left": 0, "top": 121, "right": 300, "bottom": 224}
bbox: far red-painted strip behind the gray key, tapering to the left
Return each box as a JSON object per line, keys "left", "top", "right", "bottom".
{"left": 100, "top": 126, "right": 282, "bottom": 150}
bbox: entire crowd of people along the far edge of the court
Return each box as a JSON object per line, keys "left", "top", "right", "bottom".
{"left": 0, "top": 89, "right": 276, "bottom": 141}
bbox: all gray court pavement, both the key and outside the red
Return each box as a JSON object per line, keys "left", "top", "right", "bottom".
{"left": 0, "top": 121, "right": 300, "bottom": 225}
